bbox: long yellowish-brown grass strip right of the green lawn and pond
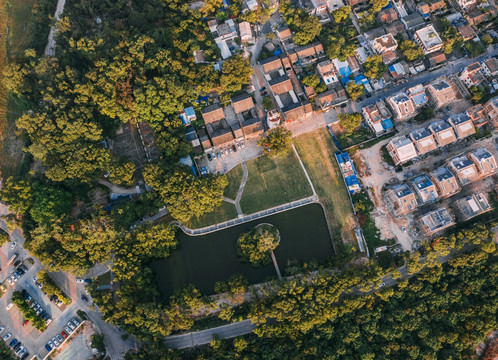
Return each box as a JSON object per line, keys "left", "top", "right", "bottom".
{"left": 294, "top": 129, "right": 353, "bottom": 242}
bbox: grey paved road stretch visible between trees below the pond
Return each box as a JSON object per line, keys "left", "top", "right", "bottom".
{"left": 165, "top": 320, "right": 256, "bottom": 349}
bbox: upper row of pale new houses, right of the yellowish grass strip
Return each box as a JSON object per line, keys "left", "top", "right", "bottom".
{"left": 386, "top": 93, "right": 498, "bottom": 166}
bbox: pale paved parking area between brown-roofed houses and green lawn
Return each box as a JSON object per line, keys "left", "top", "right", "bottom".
{"left": 195, "top": 139, "right": 263, "bottom": 174}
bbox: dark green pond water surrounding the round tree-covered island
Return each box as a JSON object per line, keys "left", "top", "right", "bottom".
{"left": 152, "top": 204, "right": 334, "bottom": 300}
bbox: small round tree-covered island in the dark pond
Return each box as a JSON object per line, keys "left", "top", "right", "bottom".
{"left": 237, "top": 224, "right": 280, "bottom": 267}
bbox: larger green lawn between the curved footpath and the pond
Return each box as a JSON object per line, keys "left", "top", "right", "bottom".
{"left": 240, "top": 152, "right": 313, "bottom": 214}
